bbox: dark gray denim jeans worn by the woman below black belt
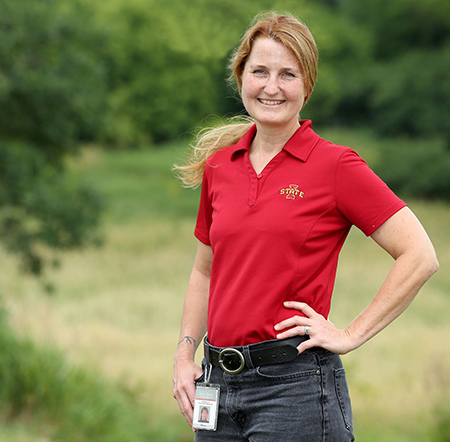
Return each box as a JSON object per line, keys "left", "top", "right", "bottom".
{"left": 195, "top": 348, "right": 355, "bottom": 442}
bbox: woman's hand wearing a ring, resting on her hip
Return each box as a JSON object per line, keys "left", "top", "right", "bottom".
{"left": 275, "top": 301, "right": 356, "bottom": 354}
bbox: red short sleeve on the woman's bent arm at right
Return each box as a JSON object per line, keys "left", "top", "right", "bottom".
{"left": 336, "top": 149, "right": 406, "bottom": 236}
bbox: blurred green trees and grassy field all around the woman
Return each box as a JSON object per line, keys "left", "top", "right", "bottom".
{"left": 0, "top": 0, "right": 450, "bottom": 442}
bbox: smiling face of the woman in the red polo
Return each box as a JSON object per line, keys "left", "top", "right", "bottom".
{"left": 241, "top": 37, "right": 306, "bottom": 131}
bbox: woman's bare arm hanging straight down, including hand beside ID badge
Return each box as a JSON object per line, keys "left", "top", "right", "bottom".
{"left": 173, "top": 242, "right": 213, "bottom": 425}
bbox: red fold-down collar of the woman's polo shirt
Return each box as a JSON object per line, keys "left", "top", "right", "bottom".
{"left": 231, "top": 120, "right": 320, "bottom": 162}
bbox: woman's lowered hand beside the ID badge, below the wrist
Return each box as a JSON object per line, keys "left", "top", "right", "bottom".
{"left": 173, "top": 355, "right": 202, "bottom": 427}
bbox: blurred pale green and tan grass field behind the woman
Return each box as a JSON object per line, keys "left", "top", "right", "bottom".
{"left": 0, "top": 133, "right": 450, "bottom": 442}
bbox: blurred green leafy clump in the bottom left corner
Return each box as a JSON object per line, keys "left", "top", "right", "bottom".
{"left": 0, "top": 309, "right": 152, "bottom": 442}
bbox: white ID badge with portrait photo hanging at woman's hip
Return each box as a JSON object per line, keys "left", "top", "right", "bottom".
{"left": 192, "top": 383, "right": 220, "bottom": 431}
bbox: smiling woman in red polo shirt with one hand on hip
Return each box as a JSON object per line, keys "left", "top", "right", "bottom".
{"left": 173, "top": 13, "right": 438, "bottom": 442}
